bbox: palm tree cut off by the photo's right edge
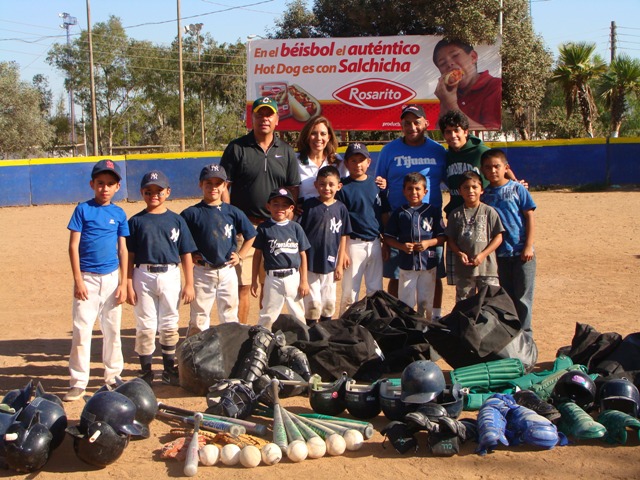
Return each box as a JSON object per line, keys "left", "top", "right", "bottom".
{"left": 600, "top": 55, "right": 640, "bottom": 138}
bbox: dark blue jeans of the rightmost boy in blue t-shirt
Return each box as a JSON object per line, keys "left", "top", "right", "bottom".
{"left": 498, "top": 255, "right": 536, "bottom": 332}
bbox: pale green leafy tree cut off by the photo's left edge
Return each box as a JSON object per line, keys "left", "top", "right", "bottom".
{"left": 0, "top": 62, "right": 52, "bottom": 158}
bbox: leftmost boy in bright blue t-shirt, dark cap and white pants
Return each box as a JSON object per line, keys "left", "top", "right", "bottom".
{"left": 63, "top": 160, "right": 129, "bottom": 402}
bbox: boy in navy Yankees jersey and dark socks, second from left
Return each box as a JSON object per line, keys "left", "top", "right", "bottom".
{"left": 127, "top": 170, "right": 197, "bottom": 385}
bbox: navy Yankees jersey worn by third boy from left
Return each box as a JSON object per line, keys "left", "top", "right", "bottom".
{"left": 180, "top": 201, "right": 256, "bottom": 266}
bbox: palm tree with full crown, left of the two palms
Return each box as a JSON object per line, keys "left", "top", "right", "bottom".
{"left": 551, "top": 42, "right": 606, "bottom": 137}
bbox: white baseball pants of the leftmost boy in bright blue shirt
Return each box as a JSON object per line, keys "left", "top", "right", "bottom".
{"left": 69, "top": 270, "right": 124, "bottom": 390}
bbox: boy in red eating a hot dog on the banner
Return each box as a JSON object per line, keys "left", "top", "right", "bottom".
{"left": 433, "top": 39, "right": 502, "bottom": 130}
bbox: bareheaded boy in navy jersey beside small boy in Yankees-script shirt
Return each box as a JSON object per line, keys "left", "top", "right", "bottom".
{"left": 300, "top": 165, "right": 351, "bottom": 325}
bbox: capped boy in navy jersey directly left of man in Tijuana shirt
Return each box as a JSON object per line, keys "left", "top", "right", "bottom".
{"left": 336, "top": 143, "right": 390, "bottom": 315}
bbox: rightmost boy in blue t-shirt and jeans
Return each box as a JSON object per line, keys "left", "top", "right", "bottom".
{"left": 481, "top": 148, "right": 536, "bottom": 333}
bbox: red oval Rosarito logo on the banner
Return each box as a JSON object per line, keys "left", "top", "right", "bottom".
{"left": 333, "top": 78, "right": 416, "bottom": 110}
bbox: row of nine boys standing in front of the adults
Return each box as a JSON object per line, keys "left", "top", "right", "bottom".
{"left": 64, "top": 143, "right": 535, "bottom": 401}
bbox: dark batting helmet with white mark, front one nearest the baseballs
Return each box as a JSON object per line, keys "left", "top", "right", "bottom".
{"left": 67, "top": 422, "right": 129, "bottom": 468}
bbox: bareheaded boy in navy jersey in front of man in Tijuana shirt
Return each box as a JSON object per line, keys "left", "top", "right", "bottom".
{"left": 384, "top": 172, "right": 445, "bottom": 320}
